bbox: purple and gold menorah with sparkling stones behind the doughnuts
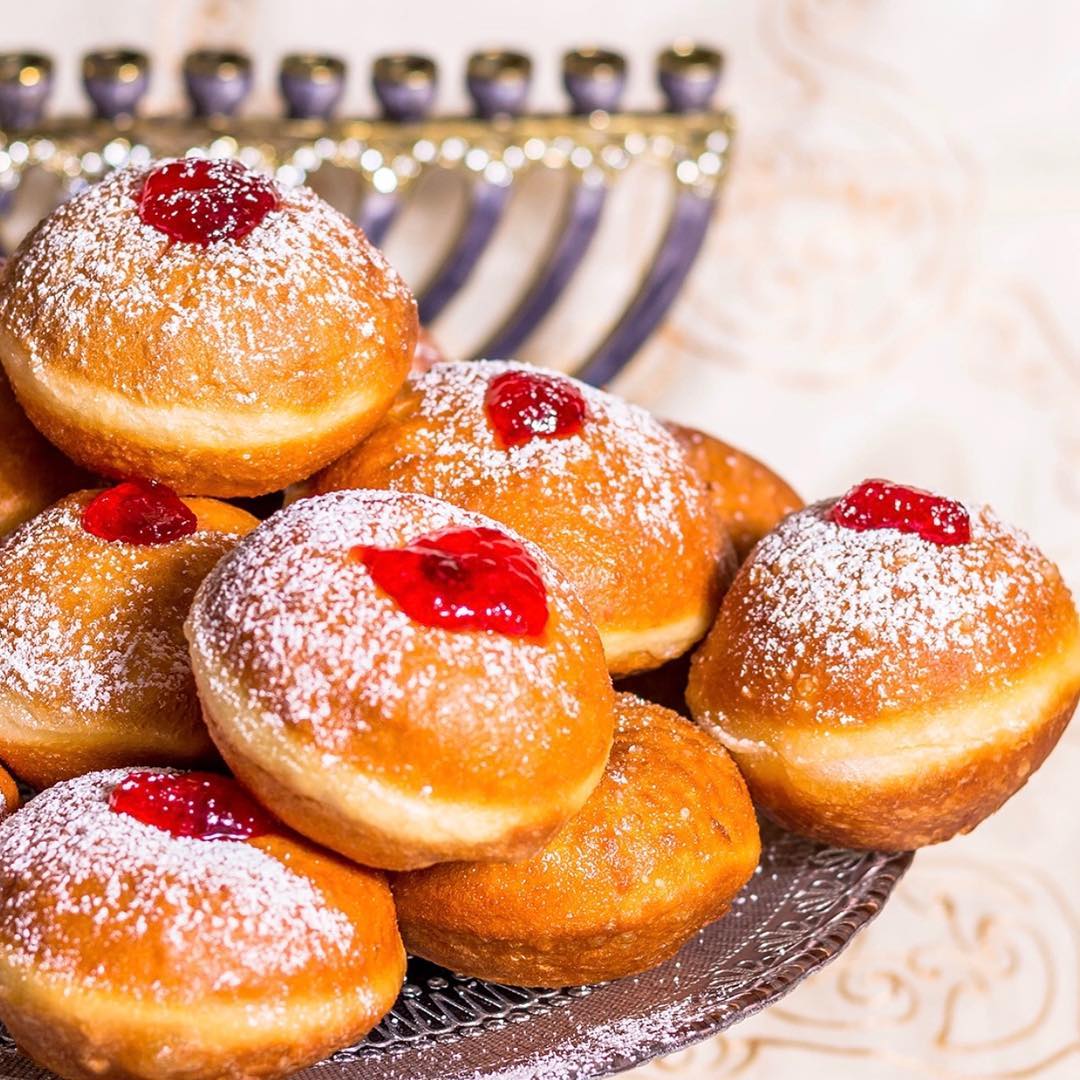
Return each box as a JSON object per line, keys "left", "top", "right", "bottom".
{"left": 0, "top": 44, "right": 734, "bottom": 384}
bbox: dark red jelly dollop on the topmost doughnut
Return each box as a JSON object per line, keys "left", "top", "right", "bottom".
{"left": 138, "top": 158, "right": 279, "bottom": 245}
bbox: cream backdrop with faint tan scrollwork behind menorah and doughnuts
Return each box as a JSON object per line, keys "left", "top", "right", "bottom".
{"left": 8, "top": 0, "right": 1080, "bottom": 1080}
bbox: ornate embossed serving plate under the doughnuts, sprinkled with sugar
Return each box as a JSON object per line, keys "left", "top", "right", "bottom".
{"left": 0, "top": 824, "right": 912, "bottom": 1080}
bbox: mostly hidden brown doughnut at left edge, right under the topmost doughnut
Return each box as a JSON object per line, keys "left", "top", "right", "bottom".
{"left": 0, "top": 372, "right": 87, "bottom": 537}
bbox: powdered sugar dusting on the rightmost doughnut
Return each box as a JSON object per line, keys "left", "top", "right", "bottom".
{"left": 721, "top": 500, "right": 1064, "bottom": 720}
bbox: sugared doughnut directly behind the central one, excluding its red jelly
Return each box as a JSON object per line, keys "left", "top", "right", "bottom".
{"left": 311, "top": 361, "right": 732, "bottom": 675}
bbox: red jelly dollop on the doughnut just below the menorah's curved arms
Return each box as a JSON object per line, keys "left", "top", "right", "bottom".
{"left": 484, "top": 372, "right": 588, "bottom": 446}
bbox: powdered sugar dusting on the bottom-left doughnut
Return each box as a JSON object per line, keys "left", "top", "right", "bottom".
{"left": 0, "top": 769, "right": 353, "bottom": 998}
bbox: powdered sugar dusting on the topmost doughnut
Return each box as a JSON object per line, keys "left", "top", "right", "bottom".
{"left": 0, "top": 162, "right": 408, "bottom": 405}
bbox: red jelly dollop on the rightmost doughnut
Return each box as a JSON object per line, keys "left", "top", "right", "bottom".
{"left": 829, "top": 480, "right": 971, "bottom": 546}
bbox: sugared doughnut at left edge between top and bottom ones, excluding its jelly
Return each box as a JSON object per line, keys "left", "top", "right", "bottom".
{"left": 0, "top": 490, "right": 257, "bottom": 787}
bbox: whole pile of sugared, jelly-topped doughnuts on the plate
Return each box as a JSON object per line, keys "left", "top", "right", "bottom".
{"left": 0, "top": 158, "right": 1080, "bottom": 1080}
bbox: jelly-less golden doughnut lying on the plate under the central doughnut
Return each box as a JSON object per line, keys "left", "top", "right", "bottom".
{"left": 391, "top": 693, "right": 760, "bottom": 986}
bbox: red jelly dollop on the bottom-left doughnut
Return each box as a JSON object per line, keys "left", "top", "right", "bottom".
{"left": 109, "top": 772, "right": 276, "bottom": 840}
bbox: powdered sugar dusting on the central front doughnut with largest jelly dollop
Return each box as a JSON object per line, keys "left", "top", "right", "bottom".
{"left": 189, "top": 491, "right": 599, "bottom": 756}
